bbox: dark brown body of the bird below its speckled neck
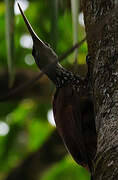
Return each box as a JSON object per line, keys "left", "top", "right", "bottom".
{"left": 53, "top": 85, "right": 96, "bottom": 171}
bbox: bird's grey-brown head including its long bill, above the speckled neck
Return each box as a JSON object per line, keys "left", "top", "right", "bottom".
{"left": 18, "top": 4, "right": 58, "bottom": 71}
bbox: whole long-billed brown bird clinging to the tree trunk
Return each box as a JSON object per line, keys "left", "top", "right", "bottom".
{"left": 18, "top": 4, "right": 96, "bottom": 174}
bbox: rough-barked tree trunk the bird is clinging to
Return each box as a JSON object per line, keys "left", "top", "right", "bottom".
{"left": 83, "top": 0, "right": 118, "bottom": 180}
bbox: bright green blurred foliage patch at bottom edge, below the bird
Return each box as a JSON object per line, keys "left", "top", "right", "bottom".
{"left": 41, "top": 156, "right": 89, "bottom": 180}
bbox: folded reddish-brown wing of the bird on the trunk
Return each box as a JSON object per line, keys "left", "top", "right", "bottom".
{"left": 53, "top": 87, "right": 88, "bottom": 167}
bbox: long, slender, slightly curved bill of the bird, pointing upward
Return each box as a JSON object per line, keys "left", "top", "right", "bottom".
{"left": 18, "top": 3, "right": 46, "bottom": 46}
